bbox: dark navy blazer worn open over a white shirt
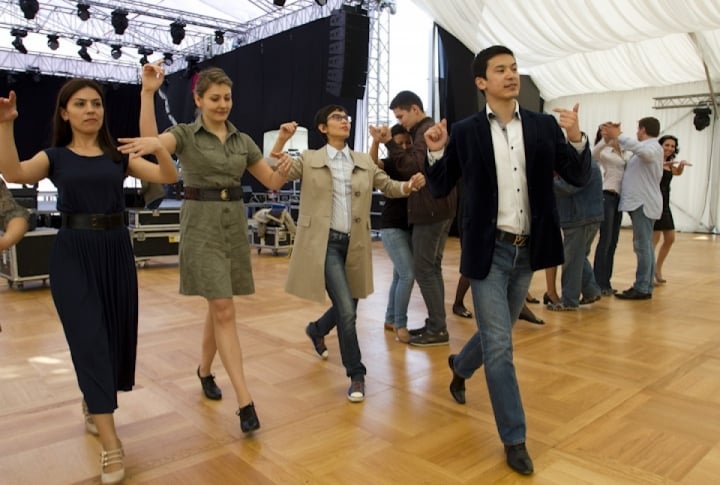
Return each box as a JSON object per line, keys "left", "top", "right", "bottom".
{"left": 426, "top": 108, "right": 590, "bottom": 279}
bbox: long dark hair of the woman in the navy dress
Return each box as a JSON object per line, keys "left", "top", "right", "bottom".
{"left": 52, "top": 78, "right": 122, "bottom": 162}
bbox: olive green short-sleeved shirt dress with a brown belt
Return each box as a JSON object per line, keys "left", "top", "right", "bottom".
{"left": 167, "top": 117, "right": 263, "bottom": 298}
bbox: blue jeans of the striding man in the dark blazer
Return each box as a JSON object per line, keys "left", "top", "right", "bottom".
{"left": 454, "top": 241, "right": 532, "bottom": 445}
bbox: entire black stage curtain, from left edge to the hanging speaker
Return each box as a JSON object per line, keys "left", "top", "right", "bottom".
{"left": 0, "top": 18, "right": 366, "bottom": 190}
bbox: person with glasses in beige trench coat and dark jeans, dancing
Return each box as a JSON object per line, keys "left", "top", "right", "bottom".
{"left": 272, "top": 105, "right": 425, "bottom": 402}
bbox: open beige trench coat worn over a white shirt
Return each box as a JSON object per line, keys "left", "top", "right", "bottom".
{"left": 285, "top": 147, "right": 407, "bottom": 303}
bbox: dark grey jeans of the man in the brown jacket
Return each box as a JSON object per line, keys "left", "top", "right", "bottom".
{"left": 412, "top": 219, "right": 452, "bottom": 333}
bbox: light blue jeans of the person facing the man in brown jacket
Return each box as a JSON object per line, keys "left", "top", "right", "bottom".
{"left": 380, "top": 227, "right": 415, "bottom": 328}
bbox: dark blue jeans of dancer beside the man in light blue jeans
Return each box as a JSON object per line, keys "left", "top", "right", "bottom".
{"left": 593, "top": 191, "right": 622, "bottom": 290}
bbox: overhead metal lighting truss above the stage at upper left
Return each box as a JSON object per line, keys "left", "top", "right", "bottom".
{"left": 0, "top": 0, "right": 343, "bottom": 83}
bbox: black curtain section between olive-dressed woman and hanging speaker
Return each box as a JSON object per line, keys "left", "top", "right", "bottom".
{"left": 162, "top": 18, "right": 356, "bottom": 191}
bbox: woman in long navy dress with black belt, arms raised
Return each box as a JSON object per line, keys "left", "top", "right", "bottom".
{"left": 0, "top": 79, "right": 177, "bottom": 483}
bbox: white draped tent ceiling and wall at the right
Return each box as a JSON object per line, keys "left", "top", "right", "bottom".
{"left": 412, "top": 0, "right": 720, "bottom": 232}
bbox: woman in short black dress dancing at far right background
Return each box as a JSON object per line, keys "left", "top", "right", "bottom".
{"left": 653, "top": 135, "right": 692, "bottom": 284}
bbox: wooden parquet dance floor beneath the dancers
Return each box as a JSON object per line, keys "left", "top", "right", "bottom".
{"left": 0, "top": 229, "right": 720, "bottom": 485}
